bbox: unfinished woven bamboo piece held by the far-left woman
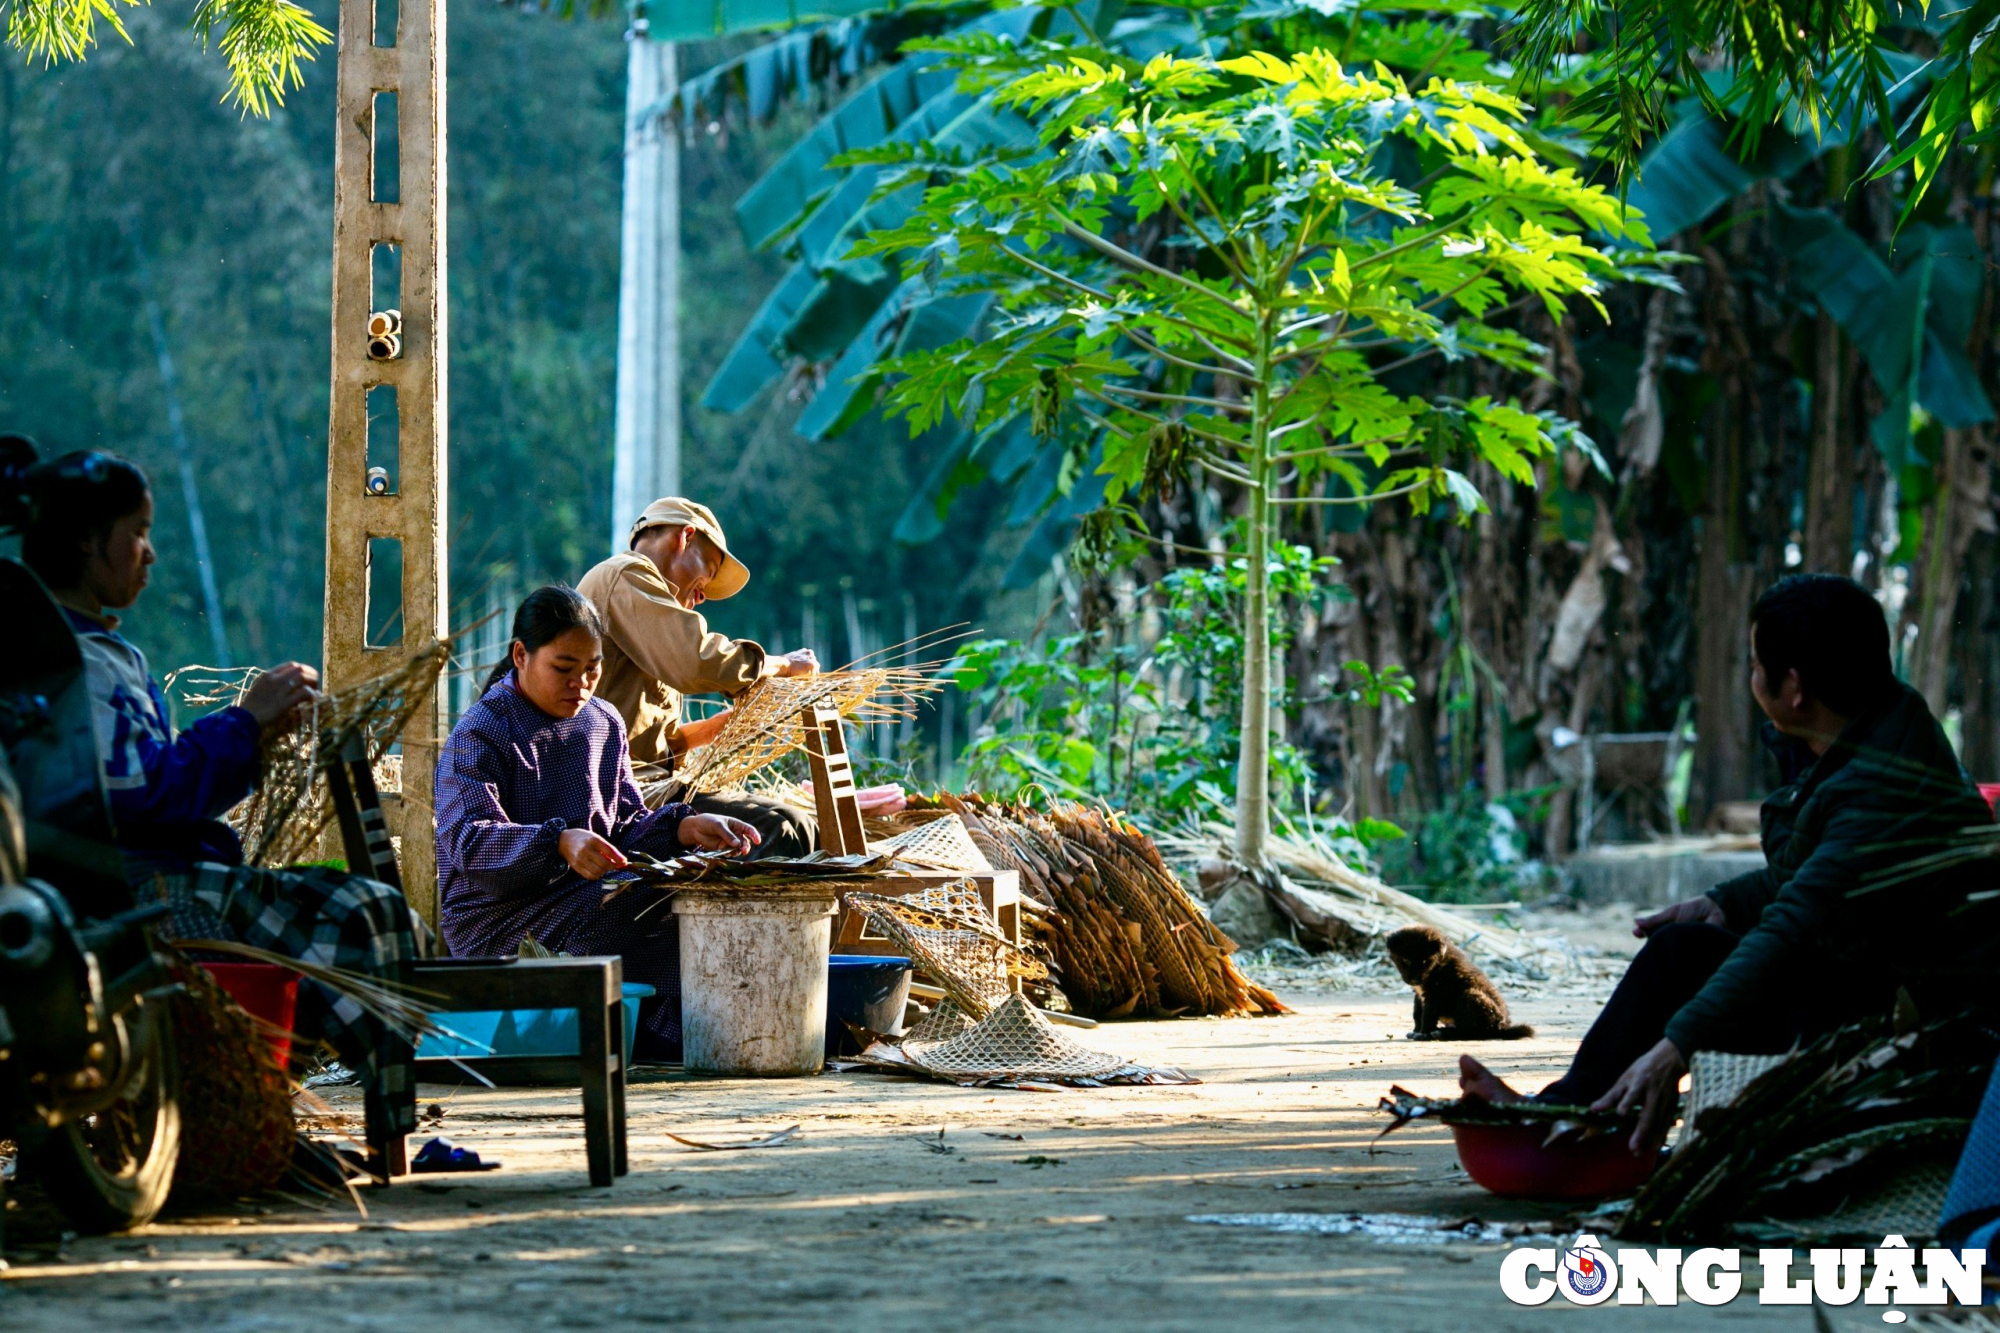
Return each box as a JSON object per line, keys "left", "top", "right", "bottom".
{"left": 166, "top": 638, "right": 452, "bottom": 867}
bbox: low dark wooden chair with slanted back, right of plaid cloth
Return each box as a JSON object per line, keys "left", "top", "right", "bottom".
{"left": 326, "top": 737, "right": 630, "bottom": 1187}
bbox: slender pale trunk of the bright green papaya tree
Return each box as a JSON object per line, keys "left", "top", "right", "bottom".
{"left": 1236, "top": 314, "right": 1274, "bottom": 871}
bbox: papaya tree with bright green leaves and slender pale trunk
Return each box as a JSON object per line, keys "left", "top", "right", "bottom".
{"left": 848, "top": 38, "right": 1664, "bottom": 867}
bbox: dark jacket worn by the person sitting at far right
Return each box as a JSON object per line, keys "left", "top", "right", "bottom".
{"left": 1666, "top": 685, "right": 2000, "bottom": 1057}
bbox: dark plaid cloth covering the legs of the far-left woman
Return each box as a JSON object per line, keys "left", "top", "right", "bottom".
{"left": 154, "top": 863, "right": 416, "bottom": 1135}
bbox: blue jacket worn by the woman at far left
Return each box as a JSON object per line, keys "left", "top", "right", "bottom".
{"left": 64, "top": 608, "right": 262, "bottom": 879}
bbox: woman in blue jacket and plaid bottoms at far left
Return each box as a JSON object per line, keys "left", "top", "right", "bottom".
{"left": 8, "top": 436, "right": 416, "bottom": 1133}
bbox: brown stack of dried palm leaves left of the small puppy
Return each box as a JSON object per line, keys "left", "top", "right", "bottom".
{"left": 938, "top": 795, "right": 1286, "bottom": 1019}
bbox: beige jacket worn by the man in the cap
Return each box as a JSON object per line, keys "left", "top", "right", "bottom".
{"left": 576, "top": 550, "right": 764, "bottom": 765}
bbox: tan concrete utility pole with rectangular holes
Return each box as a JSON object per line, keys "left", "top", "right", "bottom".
{"left": 326, "top": 0, "right": 450, "bottom": 925}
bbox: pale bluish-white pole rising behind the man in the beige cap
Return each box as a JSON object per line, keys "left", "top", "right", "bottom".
{"left": 610, "top": 0, "right": 680, "bottom": 550}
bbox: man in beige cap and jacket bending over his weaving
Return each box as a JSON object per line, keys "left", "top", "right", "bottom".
{"left": 576, "top": 496, "right": 820, "bottom": 857}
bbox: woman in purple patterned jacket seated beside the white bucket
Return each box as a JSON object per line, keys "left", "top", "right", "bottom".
{"left": 438, "top": 584, "right": 758, "bottom": 1061}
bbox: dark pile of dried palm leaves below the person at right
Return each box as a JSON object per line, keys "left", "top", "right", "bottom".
{"left": 1618, "top": 1019, "right": 1994, "bottom": 1245}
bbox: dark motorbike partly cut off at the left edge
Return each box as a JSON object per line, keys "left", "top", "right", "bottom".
{"left": 0, "top": 560, "right": 180, "bottom": 1233}
